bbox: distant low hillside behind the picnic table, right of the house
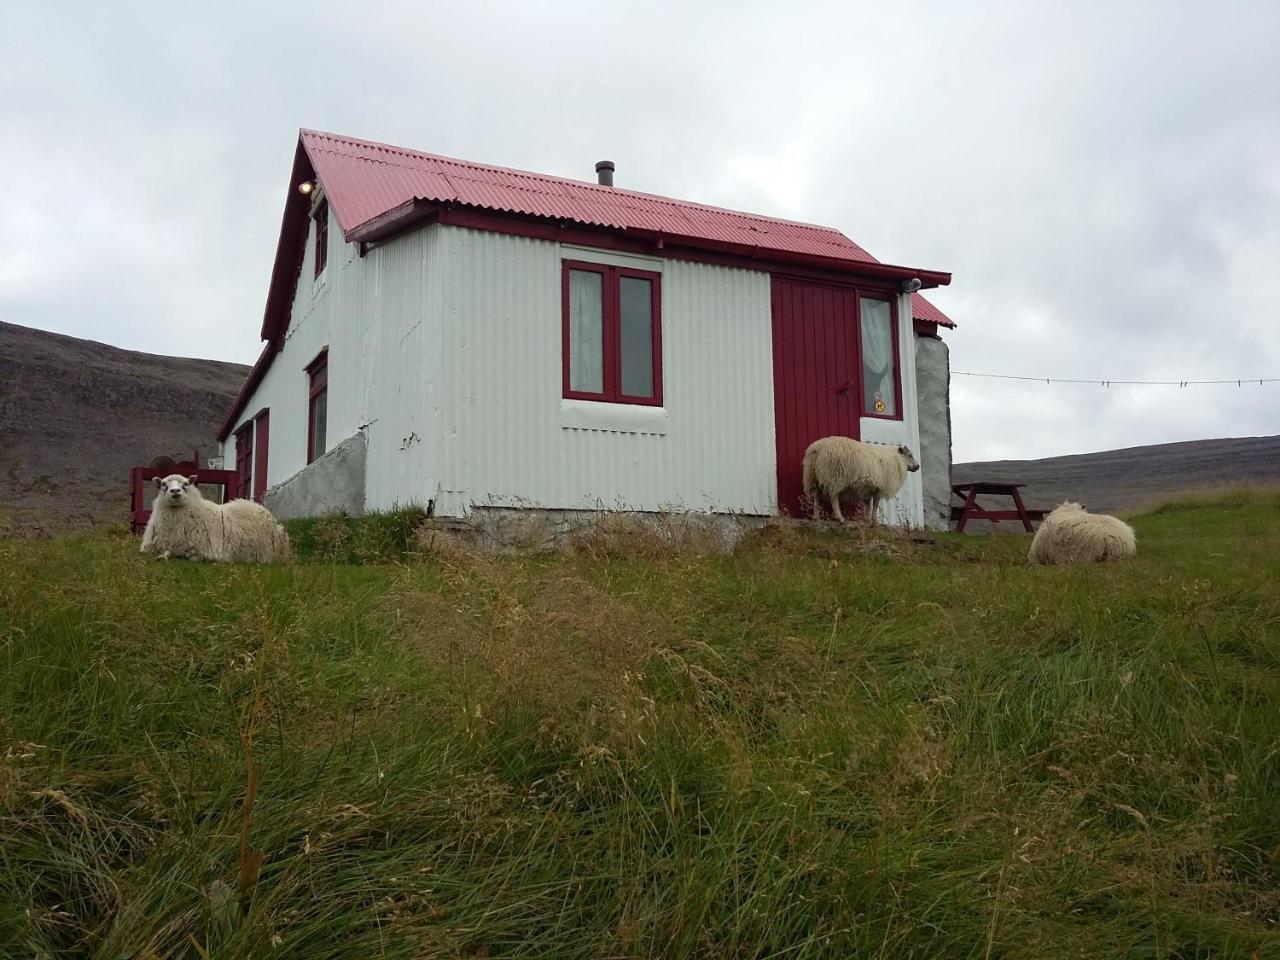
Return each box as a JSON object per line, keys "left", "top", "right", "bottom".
{"left": 951, "top": 436, "right": 1280, "bottom": 519}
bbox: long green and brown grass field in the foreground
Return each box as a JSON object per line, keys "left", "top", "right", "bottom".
{"left": 0, "top": 492, "right": 1280, "bottom": 960}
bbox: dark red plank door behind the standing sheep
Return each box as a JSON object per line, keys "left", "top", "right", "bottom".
{"left": 773, "top": 278, "right": 859, "bottom": 516}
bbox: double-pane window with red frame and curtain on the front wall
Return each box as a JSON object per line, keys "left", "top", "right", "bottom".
{"left": 562, "top": 260, "right": 662, "bottom": 406}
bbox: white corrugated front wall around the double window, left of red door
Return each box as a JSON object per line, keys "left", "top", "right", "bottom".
{"left": 438, "top": 228, "right": 776, "bottom": 513}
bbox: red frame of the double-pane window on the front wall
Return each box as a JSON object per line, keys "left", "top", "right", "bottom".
{"left": 561, "top": 260, "right": 662, "bottom": 407}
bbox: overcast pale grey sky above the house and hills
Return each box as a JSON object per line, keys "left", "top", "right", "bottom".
{"left": 0, "top": 0, "right": 1280, "bottom": 461}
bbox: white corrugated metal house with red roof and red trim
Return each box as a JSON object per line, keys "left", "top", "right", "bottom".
{"left": 220, "top": 131, "right": 952, "bottom": 525}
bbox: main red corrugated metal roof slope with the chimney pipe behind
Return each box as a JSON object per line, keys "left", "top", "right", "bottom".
{"left": 302, "top": 129, "right": 878, "bottom": 264}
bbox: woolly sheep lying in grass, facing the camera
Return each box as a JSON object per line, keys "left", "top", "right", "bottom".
{"left": 142, "top": 474, "right": 289, "bottom": 563}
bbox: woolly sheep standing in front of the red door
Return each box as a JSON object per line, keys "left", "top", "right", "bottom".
{"left": 804, "top": 436, "right": 920, "bottom": 524}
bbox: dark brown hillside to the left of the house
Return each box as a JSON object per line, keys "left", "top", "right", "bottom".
{"left": 0, "top": 323, "right": 248, "bottom": 534}
